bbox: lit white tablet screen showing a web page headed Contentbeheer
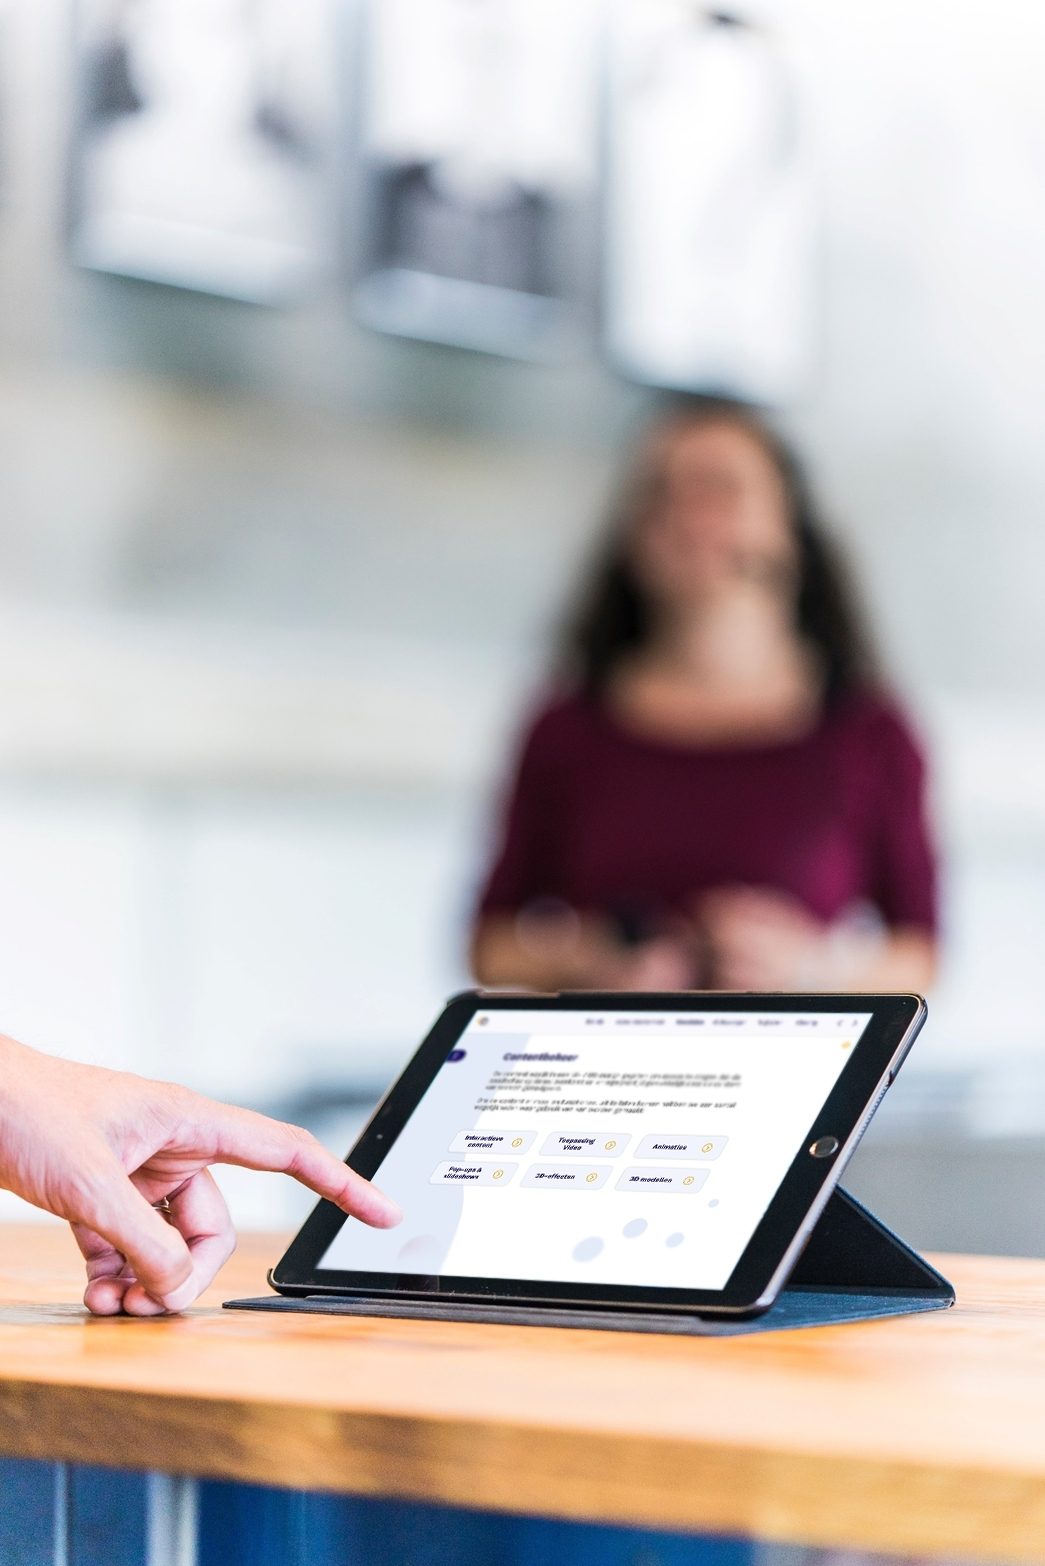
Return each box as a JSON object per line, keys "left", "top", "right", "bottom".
{"left": 321, "top": 1009, "right": 871, "bottom": 1289}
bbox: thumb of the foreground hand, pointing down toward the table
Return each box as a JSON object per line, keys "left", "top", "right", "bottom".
{"left": 71, "top": 1159, "right": 193, "bottom": 1309}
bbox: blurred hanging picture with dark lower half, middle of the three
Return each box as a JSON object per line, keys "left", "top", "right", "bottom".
{"left": 354, "top": 0, "right": 600, "bottom": 357}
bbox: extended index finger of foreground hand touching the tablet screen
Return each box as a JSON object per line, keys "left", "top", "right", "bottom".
{"left": 181, "top": 1104, "right": 403, "bottom": 1229}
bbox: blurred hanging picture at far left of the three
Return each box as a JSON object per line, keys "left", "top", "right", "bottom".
{"left": 69, "top": 0, "right": 335, "bottom": 302}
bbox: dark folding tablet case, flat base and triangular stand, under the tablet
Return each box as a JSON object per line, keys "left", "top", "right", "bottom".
{"left": 224, "top": 1187, "right": 954, "bottom": 1337}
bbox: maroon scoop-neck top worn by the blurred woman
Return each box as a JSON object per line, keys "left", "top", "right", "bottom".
{"left": 479, "top": 692, "right": 937, "bottom": 932}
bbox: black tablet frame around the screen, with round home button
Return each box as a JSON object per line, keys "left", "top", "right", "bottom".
{"left": 269, "top": 990, "right": 926, "bottom": 1315}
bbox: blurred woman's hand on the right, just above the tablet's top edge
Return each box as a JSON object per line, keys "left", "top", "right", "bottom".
{"left": 699, "top": 886, "right": 840, "bottom": 990}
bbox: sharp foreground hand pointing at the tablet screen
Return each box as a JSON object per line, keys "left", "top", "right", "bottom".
{"left": 0, "top": 1038, "right": 401, "bottom": 1315}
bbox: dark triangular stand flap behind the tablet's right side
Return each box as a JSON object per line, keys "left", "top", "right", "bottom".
{"left": 788, "top": 1187, "right": 954, "bottom": 1303}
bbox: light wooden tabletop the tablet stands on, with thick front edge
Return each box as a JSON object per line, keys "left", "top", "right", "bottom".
{"left": 0, "top": 1226, "right": 1045, "bottom": 1560}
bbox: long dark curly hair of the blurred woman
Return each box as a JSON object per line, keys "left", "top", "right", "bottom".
{"left": 559, "top": 402, "right": 877, "bottom": 702}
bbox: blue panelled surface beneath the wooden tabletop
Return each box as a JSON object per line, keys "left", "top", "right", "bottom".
{"left": 0, "top": 1458, "right": 752, "bottom": 1566}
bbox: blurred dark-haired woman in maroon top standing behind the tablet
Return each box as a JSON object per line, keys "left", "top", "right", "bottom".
{"left": 472, "top": 404, "right": 937, "bottom": 990}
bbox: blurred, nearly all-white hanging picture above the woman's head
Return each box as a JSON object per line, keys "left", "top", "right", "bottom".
{"left": 603, "top": 0, "right": 816, "bottom": 404}
